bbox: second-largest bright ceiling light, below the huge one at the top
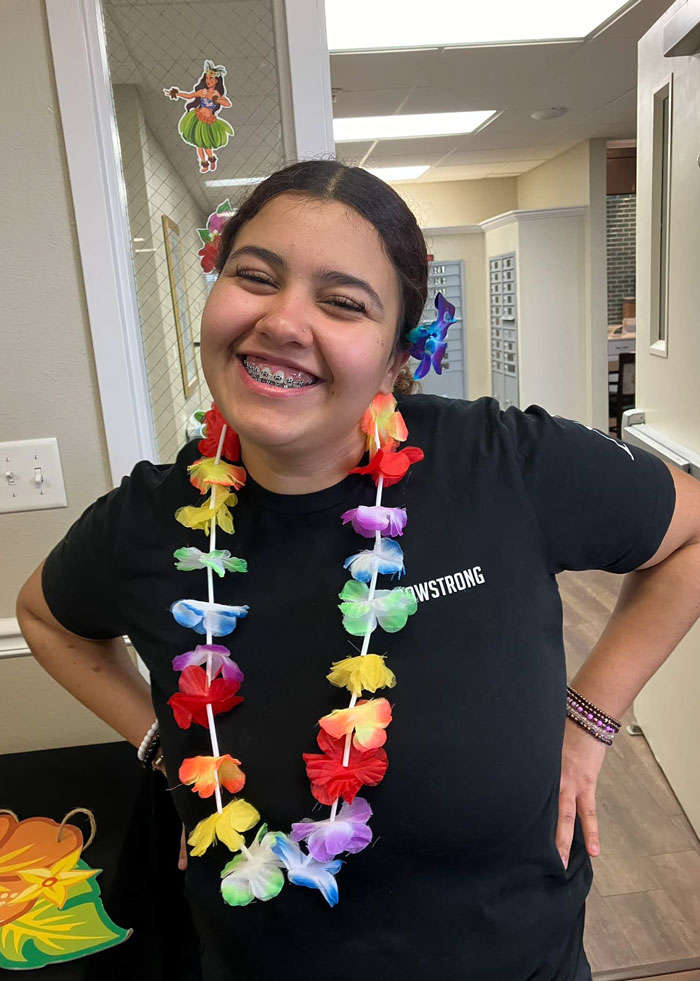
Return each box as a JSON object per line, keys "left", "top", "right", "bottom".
{"left": 334, "top": 109, "right": 497, "bottom": 143}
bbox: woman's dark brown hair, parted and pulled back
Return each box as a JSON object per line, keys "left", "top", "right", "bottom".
{"left": 216, "top": 160, "right": 428, "bottom": 393}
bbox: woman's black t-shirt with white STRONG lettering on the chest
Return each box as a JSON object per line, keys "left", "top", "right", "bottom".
{"left": 43, "top": 396, "right": 675, "bottom": 981}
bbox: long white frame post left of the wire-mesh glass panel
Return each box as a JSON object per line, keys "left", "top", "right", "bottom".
{"left": 46, "top": 0, "right": 156, "bottom": 486}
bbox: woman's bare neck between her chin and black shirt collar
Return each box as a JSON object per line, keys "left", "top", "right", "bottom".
{"left": 240, "top": 428, "right": 365, "bottom": 494}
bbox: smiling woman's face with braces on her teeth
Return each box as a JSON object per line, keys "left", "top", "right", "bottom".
{"left": 201, "top": 193, "right": 406, "bottom": 464}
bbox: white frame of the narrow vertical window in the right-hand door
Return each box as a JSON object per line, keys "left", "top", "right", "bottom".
{"left": 649, "top": 72, "right": 673, "bottom": 358}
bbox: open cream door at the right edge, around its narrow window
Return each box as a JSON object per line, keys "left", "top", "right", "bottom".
{"left": 634, "top": 0, "right": 700, "bottom": 835}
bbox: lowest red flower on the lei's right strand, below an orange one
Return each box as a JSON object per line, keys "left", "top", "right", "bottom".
{"left": 303, "top": 729, "right": 389, "bottom": 807}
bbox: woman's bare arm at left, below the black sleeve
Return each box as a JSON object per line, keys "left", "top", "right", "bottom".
{"left": 16, "top": 562, "right": 154, "bottom": 746}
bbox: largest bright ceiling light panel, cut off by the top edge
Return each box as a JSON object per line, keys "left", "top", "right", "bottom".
{"left": 325, "top": 0, "right": 628, "bottom": 51}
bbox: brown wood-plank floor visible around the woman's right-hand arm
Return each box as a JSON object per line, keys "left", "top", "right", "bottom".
{"left": 557, "top": 571, "right": 700, "bottom": 981}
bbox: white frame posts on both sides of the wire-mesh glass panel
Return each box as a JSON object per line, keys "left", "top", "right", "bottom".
{"left": 46, "top": 0, "right": 335, "bottom": 486}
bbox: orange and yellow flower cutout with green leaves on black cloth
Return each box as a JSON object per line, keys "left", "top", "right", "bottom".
{"left": 0, "top": 807, "right": 131, "bottom": 971}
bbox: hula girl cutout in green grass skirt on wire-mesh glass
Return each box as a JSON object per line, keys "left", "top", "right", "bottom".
{"left": 163, "top": 61, "right": 233, "bottom": 174}
